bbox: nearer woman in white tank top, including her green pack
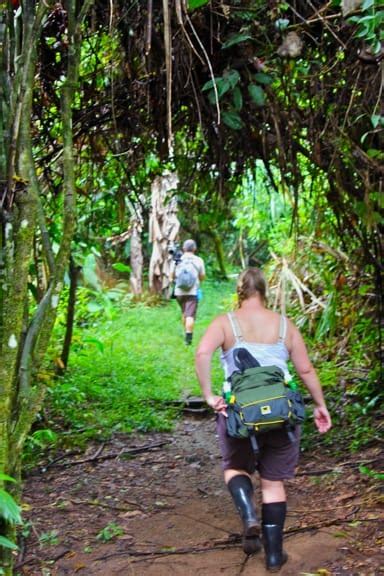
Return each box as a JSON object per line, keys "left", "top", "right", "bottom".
{"left": 196, "top": 268, "right": 331, "bottom": 571}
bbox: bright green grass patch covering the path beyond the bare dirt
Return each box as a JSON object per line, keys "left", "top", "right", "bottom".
{"left": 49, "top": 282, "right": 234, "bottom": 437}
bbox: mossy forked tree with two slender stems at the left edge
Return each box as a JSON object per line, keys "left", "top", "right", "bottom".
{"left": 0, "top": 0, "right": 91, "bottom": 576}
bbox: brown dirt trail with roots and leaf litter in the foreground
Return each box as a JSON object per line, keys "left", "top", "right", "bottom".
{"left": 15, "top": 417, "right": 384, "bottom": 576}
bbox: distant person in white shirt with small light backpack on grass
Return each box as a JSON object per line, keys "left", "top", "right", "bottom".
{"left": 173, "top": 240, "right": 205, "bottom": 345}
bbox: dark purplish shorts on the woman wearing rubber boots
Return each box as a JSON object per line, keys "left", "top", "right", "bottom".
{"left": 216, "top": 414, "right": 300, "bottom": 480}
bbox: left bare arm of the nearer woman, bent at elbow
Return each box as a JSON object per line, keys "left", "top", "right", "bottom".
{"left": 195, "top": 317, "right": 226, "bottom": 413}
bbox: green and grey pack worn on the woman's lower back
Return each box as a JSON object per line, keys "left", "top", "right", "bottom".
{"left": 227, "top": 366, "right": 305, "bottom": 452}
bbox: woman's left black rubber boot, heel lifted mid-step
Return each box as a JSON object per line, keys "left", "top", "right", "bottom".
{"left": 228, "top": 474, "right": 261, "bottom": 555}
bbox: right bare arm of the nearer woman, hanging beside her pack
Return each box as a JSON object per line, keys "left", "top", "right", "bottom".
{"left": 290, "top": 323, "right": 332, "bottom": 433}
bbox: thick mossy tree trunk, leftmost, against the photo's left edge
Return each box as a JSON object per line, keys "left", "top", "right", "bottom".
{"left": 0, "top": 3, "right": 47, "bottom": 576}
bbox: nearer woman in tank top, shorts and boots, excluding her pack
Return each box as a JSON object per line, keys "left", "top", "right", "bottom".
{"left": 196, "top": 268, "right": 331, "bottom": 572}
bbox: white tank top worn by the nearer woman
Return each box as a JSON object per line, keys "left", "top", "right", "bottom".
{"left": 220, "top": 312, "right": 291, "bottom": 380}
